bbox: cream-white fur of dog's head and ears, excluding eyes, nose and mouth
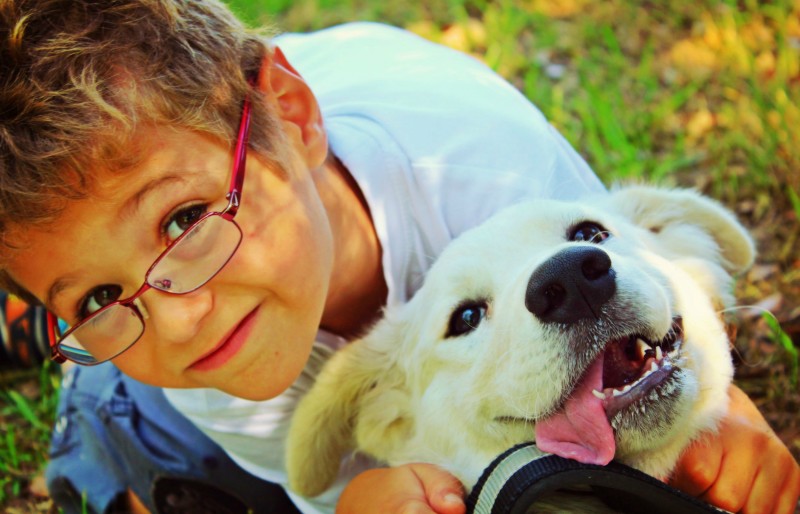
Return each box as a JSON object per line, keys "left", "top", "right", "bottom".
{"left": 287, "top": 187, "right": 754, "bottom": 496}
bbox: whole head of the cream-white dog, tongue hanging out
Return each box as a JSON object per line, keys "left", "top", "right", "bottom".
{"left": 288, "top": 187, "right": 754, "bottom": 495}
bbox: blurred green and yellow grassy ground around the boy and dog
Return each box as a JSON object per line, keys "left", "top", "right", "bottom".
{"left": 0, "top": 0, "right": 800, "bottom": 513}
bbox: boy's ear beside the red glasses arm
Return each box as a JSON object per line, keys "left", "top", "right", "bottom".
{"left": 258, "top": 46, "right": 328, "bottom": 169}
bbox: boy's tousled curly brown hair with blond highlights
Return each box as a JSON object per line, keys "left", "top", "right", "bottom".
{"left": 0, "top": 0, "right": 281, "bottom": 298}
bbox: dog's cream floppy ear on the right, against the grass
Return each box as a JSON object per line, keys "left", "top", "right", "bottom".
{"left": 611, "top": 186, "right": 755, "bottom": 274}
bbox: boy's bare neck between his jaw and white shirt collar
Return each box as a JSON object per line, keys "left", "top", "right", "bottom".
{"left": 314, "top": 154, "right": 387, "bottom": 339}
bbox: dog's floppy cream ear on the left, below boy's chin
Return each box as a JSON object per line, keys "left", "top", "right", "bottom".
{"left": 286, "top": 320, "right": 410, "bottom": 496}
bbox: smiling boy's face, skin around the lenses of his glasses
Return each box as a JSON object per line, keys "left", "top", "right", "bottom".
{"left": 8, "top": 121, "right": 333, "bottom": 399}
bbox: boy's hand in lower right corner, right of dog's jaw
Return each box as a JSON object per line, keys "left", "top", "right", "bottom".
{"left": 670, "top": 386, "right": 800, "bottom": 514}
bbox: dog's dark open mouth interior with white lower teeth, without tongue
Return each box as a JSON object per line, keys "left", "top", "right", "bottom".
{"left": 592, "top": 317, "right": 683, "bottom": 419}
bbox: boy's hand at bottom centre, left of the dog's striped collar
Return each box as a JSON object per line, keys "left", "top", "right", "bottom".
{"left": 336, "top": 464, "right": 466, "bottom": 514}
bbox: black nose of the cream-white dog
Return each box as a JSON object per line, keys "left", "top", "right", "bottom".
{"left": 525, "top": 245, "right": 617, "bottom": 323}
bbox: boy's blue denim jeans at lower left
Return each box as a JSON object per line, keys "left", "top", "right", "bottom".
{"left": 46, "top": 363, "right": 304, "bottom": 514}
